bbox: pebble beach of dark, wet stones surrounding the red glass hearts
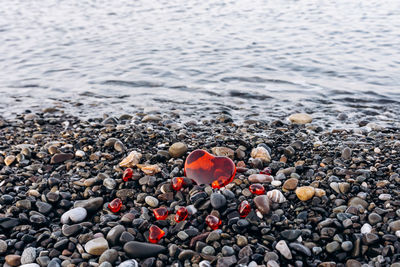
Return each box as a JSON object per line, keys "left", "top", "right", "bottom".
{"left": 0, "top": 110, "right": 400, "bottom": 267}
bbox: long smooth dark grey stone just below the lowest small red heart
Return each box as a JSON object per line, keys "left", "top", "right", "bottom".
{"left": 124, "top": 241, "right": 166, "bottom": 258}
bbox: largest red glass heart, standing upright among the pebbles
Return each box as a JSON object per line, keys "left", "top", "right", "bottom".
{"left": 185, "top": 149, "right": 236, "bottom": 188}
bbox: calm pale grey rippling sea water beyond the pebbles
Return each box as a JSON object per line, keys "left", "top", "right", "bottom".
{"left": 0, "top": 0, "right": 400, "bottom": 124}
